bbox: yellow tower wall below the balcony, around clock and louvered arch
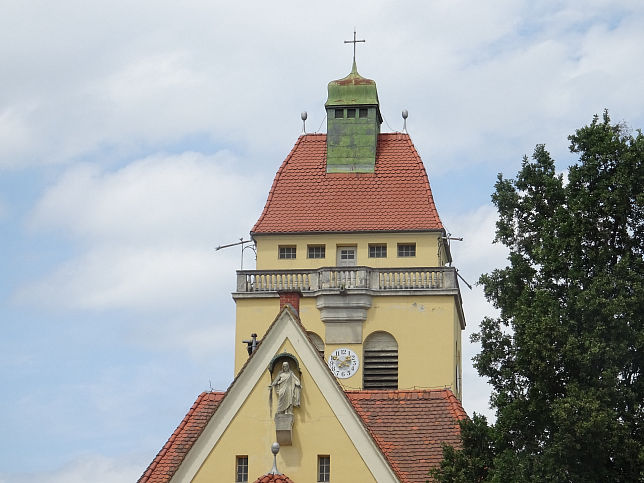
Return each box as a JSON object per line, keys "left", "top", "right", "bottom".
{"left": 235, "top": 295, "right": 461, "bottom": 396}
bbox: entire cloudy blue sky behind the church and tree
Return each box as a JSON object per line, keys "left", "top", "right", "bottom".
{"left": 0, "top": 0, "right": 644, "bottom": 483}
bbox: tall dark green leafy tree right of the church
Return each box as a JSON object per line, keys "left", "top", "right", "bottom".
{"left": 434, "top": 112, "right": 644, "bottom": 482}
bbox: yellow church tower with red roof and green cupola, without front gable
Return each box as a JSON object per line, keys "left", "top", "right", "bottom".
{"left": 233, "top": 59, "right": 465, "bottom": 399}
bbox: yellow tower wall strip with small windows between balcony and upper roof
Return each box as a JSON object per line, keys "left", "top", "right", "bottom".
{"left": 255, "top": 232, "right": 446, "bottom": 270}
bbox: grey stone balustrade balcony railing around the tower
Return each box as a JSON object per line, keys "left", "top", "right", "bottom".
{"left": 237, "top": 267, "right": 458, "bottom": 293}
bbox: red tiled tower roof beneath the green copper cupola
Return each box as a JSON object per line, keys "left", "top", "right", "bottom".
{"left": 252, "top": 133, "right": 443, "bottom": 234}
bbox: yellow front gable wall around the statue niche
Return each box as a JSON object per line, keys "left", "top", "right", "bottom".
{"left": 193, "top": 339, "right": 375, "bottom": 483}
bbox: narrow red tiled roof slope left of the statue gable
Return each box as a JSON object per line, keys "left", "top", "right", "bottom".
{"left": 139, "top": 392, "right": 226, "bottom": 483}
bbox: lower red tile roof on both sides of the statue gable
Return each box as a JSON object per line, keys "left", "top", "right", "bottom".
{"left": 139, "top": 389, "right": 467, "bottom": 483}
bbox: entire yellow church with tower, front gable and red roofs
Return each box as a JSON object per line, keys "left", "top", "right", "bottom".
{"left": 139, "top": 50, "right": 467, "bottom": 483}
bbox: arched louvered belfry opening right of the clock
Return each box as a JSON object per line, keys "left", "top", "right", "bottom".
{"left": 362, "top": 332, "right": 398, "bottom": 389}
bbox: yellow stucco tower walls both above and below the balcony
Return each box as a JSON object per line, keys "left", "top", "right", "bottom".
{"left": 235, "top": 232, "right": 461, "bottom": 397}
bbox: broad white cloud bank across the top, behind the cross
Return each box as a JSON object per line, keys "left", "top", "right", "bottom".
{"left": 0, "top": 0, "right": 644, "bottom": 170}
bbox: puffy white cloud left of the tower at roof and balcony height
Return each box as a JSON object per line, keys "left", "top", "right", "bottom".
{"left": 17, "top": 153, "right": 265, "bottom": 311}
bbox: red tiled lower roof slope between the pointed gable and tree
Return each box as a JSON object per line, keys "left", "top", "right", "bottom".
{"left": 346, "top": 389, "right": 467, "bottom": 483}
